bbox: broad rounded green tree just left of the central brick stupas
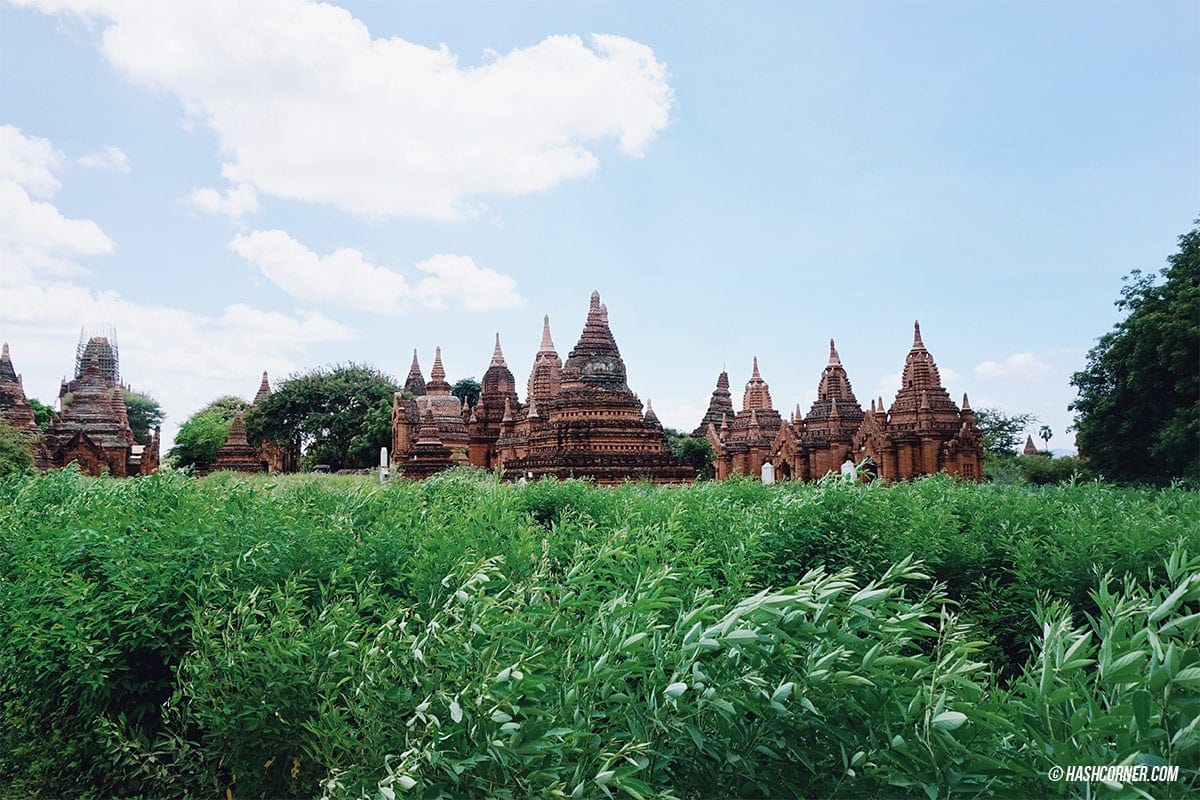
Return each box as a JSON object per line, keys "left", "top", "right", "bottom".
{"left": 246, "top": 363, "right": 398, "bottom": 470}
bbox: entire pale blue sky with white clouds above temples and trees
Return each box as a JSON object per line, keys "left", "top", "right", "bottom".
{"left": 0, "top": 0, "right": 1200, "bottom": 449}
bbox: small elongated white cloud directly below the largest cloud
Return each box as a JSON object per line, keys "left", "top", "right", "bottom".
{"left": 229, "top": 230, "right": 521, "bottom": 314}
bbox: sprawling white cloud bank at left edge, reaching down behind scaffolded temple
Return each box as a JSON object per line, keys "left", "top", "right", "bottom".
{"left": 0, "top": 126, "right": 354, "bottom": 450}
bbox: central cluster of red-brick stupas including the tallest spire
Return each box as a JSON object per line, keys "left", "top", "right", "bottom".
{"left": 392, "top": 293, "right": 696, "bottom": 485}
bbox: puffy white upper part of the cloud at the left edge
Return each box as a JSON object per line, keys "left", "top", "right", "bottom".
{"left": 0, "top": 125, "right": 116, "bottom": 282}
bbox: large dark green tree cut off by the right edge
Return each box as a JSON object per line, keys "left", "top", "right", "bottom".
{"left": 1070, "top": 219, "right": 1200, "bottom": 483}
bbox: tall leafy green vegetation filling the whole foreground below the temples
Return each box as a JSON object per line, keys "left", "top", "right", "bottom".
{"left": 0, "top": 470, "right": 1200, "bottom": 800}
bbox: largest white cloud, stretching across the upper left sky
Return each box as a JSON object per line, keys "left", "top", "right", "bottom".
{"left": 17, "top": 0, "right": 672, "bottom": 219}
